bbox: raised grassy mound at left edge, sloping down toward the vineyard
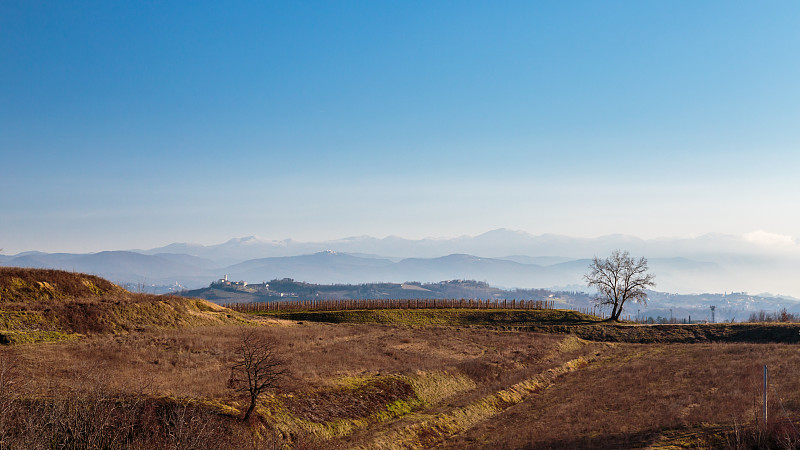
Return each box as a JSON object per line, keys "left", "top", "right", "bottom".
{"left": 0, "top": 267, "right": 244, "bottom": 344}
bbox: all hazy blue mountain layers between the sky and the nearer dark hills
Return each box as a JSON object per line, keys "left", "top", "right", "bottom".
{"left": 0, "top": 229, "right": 800, "bottom": 297}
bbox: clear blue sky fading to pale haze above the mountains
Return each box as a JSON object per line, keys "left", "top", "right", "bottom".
{"left": 0, "top": 0, "right": 800, "bottom": 254}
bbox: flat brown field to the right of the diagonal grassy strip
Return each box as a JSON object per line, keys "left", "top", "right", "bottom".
{"left": 448, "top": 344, "right": 800, "bottom": 448}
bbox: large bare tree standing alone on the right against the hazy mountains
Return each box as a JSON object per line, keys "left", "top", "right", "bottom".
{"left": 583, "top": 250, "right": 656, "bottom": 320}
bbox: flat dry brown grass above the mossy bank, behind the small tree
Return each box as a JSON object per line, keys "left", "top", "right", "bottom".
{"left": 12, "top": 324, "right": 563, "bottom": 398}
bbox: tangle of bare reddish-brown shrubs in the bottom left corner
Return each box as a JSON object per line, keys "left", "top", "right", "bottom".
{"left": 0, "top": 351, "right": 247, "bottom": 449}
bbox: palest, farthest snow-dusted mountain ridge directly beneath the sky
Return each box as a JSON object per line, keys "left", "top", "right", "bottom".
{"left": 139, "top": 229, "right": 800, "bottom": 264}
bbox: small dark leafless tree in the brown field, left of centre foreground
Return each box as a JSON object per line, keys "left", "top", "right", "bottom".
{"left": 228, "top": 327, "right": 286, "bottom": 422}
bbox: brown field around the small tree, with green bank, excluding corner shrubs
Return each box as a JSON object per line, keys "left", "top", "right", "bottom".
{"left": 6, "top": 322, "right": 607, "bottom": 448}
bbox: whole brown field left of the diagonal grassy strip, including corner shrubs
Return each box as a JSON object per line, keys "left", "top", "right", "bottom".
{"left": 9, "top": 322, "right": 608, "bottom": 448}
